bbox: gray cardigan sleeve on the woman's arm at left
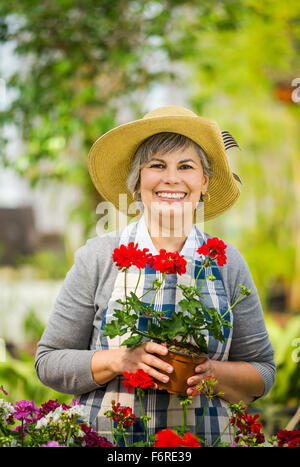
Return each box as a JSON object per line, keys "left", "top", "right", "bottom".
{"left": 35, "top": 241, "right": 105, "bottom": 394}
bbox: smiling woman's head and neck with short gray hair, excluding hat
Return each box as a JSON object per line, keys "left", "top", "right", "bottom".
{"left": 127, "top": 132, "right": 213, "bottom": 251}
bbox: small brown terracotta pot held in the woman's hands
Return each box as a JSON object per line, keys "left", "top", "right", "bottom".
{"left": 157, "top": 350, "right": 208, "bottom": 396}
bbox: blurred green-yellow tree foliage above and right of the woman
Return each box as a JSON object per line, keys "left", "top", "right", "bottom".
{"left": 0, "top": 0, "right": 300, "bottom": 428}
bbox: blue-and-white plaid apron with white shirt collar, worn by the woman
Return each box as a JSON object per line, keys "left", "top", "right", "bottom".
{"left": 79, "top": 217, "right": 232, "bottom": 446}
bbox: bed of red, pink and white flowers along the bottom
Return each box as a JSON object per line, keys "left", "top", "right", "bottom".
{"left": 0, "top": 380, "right": 300, "bottom": 447}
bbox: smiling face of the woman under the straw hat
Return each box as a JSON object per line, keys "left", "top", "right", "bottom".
{"left": 138, "top": 147, "right": 209, "bottom": 227}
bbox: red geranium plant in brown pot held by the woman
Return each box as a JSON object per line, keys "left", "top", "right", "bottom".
{"left": 104, "top": 237, "right": 250, "bottom": 394}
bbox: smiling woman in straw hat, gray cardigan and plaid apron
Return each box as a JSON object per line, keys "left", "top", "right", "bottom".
{"left": 36, "top": 106, "right": 275, "bottom": 444}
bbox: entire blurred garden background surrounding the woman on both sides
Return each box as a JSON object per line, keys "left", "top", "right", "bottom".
{"left": 0, "top": 0, "right": 300, "bottom": 431}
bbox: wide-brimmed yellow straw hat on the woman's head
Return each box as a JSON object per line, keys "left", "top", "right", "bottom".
{"left": 88, "top": 106, "right": 240, "bottom": 220}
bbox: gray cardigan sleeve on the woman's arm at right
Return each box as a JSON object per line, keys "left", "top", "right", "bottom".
{"left": 220, "top": 244, "right": 276, "bottom": 397}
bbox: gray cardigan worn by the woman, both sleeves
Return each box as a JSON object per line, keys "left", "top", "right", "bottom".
{"left": 35, "top": 232, "right": 276, "bottom": 396}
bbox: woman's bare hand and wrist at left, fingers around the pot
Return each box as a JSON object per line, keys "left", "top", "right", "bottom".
{"left": 91, "top": 342, "right": 173, "bottom": 389}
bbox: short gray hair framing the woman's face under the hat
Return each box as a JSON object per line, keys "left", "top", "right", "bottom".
{"left": 127, "top": 132, "right": 213, "bottom": 193}
